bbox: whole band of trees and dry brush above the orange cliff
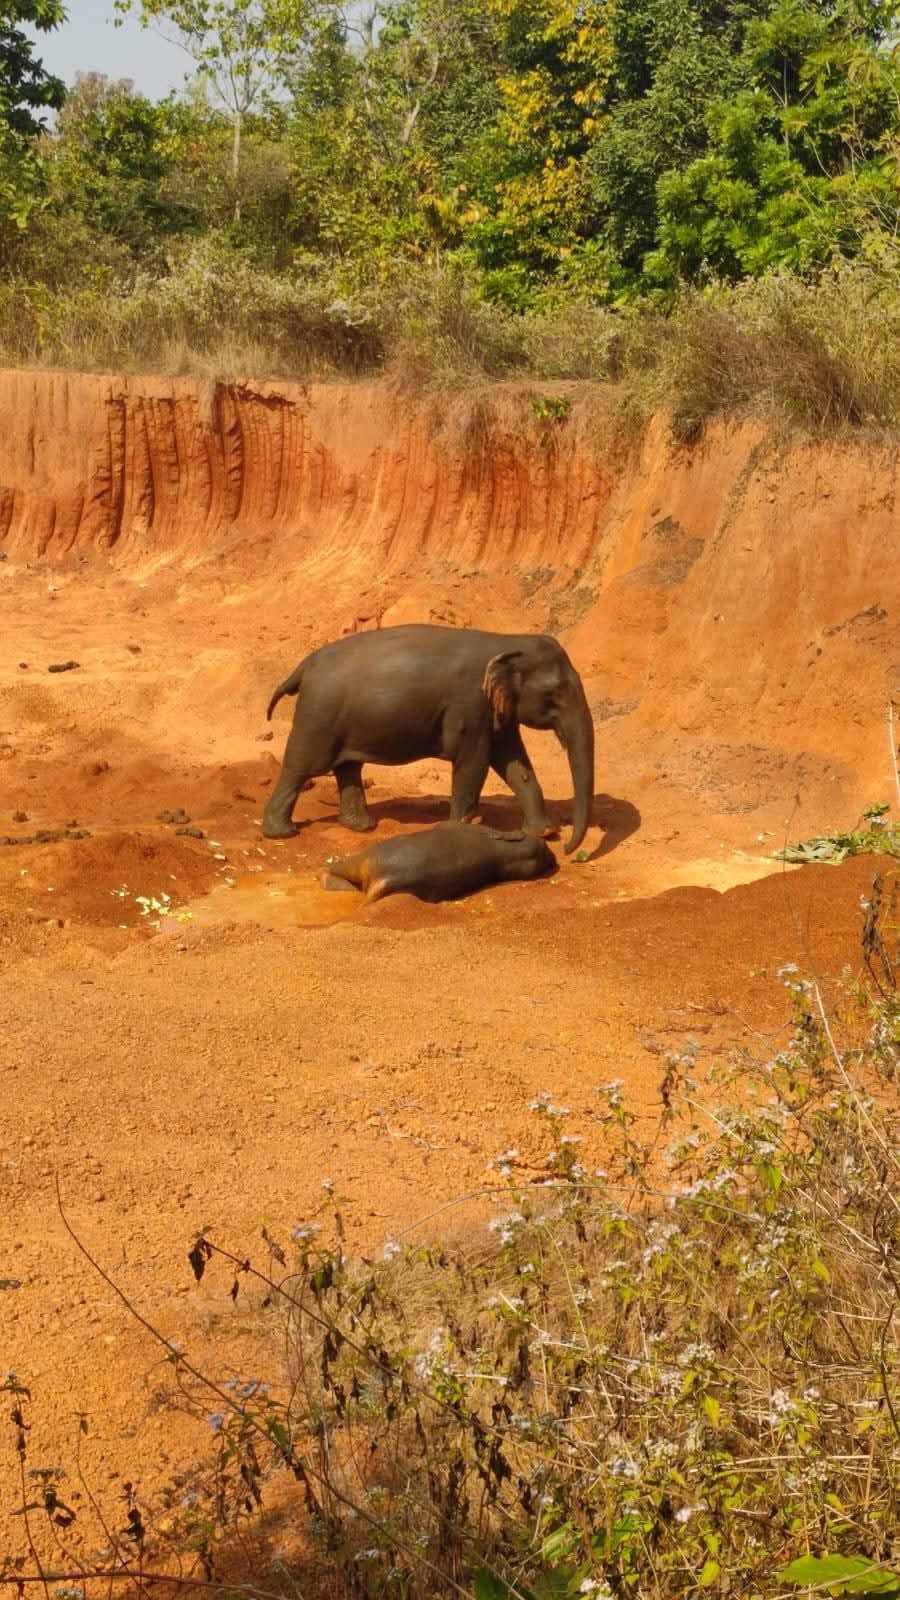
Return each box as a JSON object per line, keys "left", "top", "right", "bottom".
{"left": 0, "top": 0, "right": 900, "bottom": 425}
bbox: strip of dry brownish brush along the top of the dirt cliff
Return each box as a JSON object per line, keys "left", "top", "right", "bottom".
{"left": 0, "top": 240, "right": 900, "bottom": 442}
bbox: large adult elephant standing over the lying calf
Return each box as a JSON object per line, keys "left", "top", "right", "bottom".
{"left": 263, "top": 624, "right": 594, "bottom": 854}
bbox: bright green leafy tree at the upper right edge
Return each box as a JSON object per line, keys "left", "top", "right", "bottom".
{"left": 645, "top": 0, "right": 900, "bottom": 285}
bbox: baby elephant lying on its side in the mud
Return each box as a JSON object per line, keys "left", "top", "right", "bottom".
{"left": 322, "top": 822, "right": 556, "bottom": 901}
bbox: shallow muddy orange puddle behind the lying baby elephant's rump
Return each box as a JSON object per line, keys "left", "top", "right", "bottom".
{"left": 160, "top": 874, "right": 364, "bottom": 930}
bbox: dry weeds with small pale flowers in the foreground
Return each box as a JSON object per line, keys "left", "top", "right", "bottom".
{"left": 3, "top": 875, "right": 900, "bottom": 1600}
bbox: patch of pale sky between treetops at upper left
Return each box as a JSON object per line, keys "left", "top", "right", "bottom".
{"left": 37, "top": 0, "right": 192, "bottom": 99}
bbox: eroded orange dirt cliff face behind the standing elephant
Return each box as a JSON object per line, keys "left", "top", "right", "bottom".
{"left": 0, "top": 373, "right": 900, "bottom": 821}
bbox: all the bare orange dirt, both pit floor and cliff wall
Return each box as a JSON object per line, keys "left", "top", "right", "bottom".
{"left": 0, "top": 373, "right": 900, "bottom": 1557}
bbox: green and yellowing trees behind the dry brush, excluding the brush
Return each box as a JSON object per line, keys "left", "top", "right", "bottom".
{"left": 0, "top": 0, "right": 900, "bottom": 302}
